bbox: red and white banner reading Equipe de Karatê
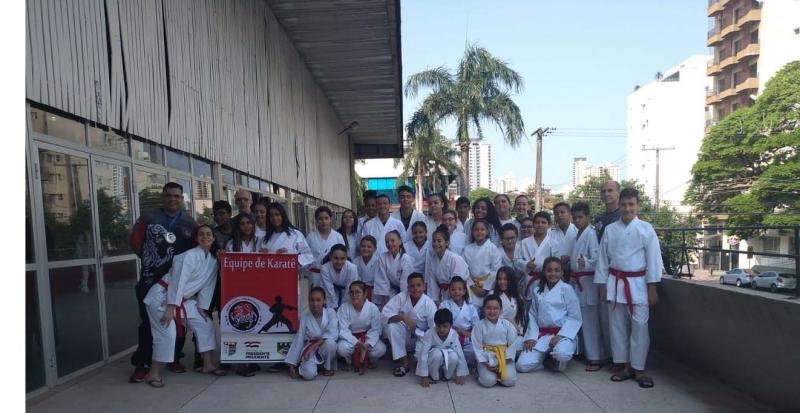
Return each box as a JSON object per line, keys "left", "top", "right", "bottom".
{"left": 220, "top": 252, "right": 300, "bottom": 363}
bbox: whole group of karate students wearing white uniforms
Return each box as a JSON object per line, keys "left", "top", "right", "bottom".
{"left": 142, "top": 181, "right": 662, "bottom": 387}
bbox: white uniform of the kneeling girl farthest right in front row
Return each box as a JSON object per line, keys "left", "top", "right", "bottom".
{"left": 517, "top": 281, "right": 583, "bottom": 373}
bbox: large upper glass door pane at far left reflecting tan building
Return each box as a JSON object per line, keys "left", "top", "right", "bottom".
{"left": 39, "top": 149, "right": 94, "bottom": 261}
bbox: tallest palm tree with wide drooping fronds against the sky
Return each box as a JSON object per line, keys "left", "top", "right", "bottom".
{"left": 405, "top": 45, "right": 526, "bottom": 195}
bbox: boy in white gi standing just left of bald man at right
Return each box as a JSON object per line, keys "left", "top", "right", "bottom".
{"left": 570, "top": 202, "right": 610, "bottom": 371}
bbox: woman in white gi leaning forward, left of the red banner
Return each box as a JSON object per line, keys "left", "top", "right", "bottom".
{"left": 143, "top": 224, "right": 225, "bottom": 387}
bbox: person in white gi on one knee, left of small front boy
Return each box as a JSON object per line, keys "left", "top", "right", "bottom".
{"left": 383, "top": 273, "right": 436, "bottom": 377}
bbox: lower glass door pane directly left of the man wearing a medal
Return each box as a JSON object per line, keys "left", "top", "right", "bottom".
{"left": 103, "top": 260, "right": 139, "bottom": 356}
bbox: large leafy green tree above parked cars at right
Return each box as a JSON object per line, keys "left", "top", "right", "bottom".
{"left": 685, "top": 61, "right": 800, "bottom": 237}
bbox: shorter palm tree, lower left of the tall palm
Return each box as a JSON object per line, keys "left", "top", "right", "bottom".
{"left": 394, "top": 127, "right": 459, "bottom": 211}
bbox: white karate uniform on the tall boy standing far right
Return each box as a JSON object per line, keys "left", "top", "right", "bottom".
{"left": 594, "top": 217, "right": 663, "bottom": 370}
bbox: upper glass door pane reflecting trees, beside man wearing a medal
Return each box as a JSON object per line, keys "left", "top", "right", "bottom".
{"left": 94, "top": 161, "right": 133, "bottom": 256}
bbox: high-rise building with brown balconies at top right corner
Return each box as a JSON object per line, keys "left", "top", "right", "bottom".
{"left": 706, "top": 0, "right": 800, "bottom": 125}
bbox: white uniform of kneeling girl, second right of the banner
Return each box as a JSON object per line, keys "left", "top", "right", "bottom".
{"left": 336, "top": 301, "right": 386, "bottom": 364}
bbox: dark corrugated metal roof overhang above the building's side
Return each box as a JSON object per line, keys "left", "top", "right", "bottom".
{"left": 267, "top": 0, "right": 403, "bottom": 158}
